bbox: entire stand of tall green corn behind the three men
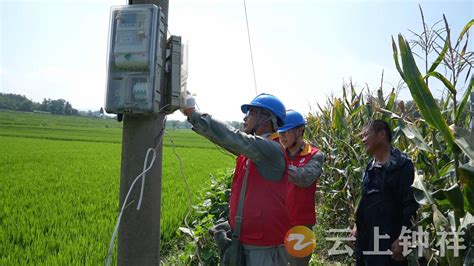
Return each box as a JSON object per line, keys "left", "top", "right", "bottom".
{"left": 306, "top": 13, "right": 474, "bottom": 265}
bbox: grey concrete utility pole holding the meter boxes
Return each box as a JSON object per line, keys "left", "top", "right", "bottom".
{"left": 117, "top": 0, "right": 169, "bottom": 265}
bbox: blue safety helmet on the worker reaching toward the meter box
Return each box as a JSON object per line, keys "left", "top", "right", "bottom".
{"left": 240, "top": 93, "right": 286, "bottom": 126}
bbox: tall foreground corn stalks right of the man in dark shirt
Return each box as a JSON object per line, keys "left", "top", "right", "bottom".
{"left": 392, "top": 16, "right": 474, "bottom": 265}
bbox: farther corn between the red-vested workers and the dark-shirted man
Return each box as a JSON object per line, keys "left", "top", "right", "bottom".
{"left": 306, "top": 82, "right": 411, "bottom": 262}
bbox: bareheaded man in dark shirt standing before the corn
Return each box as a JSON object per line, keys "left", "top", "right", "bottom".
{"left": 352, "top": 120, "right": 418, "bottom": 266}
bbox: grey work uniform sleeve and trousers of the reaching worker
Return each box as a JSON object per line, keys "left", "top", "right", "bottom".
{"left": 188, "top": 111, "right": 289, "bottom": 266}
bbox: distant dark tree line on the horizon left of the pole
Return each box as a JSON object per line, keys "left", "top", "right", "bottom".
{"left": 0, "top": 93, "right": 79, "bottom": 115}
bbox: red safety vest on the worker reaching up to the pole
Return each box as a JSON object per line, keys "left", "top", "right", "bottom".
{"left": 229, "top": 135, "right": 290, "bottom": 246}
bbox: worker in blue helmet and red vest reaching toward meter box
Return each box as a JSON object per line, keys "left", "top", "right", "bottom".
{"left": 181, "top": 93, "right": 290, "bottom": 266}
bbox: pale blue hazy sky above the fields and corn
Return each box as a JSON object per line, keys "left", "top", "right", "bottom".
{"left": 0, "top": 0, "right": 474, "bottom": 120}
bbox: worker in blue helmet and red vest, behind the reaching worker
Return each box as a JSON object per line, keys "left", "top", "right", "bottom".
{"left": 278, "top": 110, "right": 324, "bottom": 266}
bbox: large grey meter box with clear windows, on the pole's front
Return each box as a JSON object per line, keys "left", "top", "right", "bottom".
{"left": 105, "top": 4, "right": 165, "bottom": 114}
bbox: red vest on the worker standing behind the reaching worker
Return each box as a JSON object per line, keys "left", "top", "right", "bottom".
{"left": 287, "top": 143, "right": 319, "bottom": 226}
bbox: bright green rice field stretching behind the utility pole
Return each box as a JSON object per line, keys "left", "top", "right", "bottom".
{"left": 0, "top": 111, "right": 234, "bottom": 265}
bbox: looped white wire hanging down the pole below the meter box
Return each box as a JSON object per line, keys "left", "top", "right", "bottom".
{"left": 106, "top": 148, "right": 156, "bottom": 266}
